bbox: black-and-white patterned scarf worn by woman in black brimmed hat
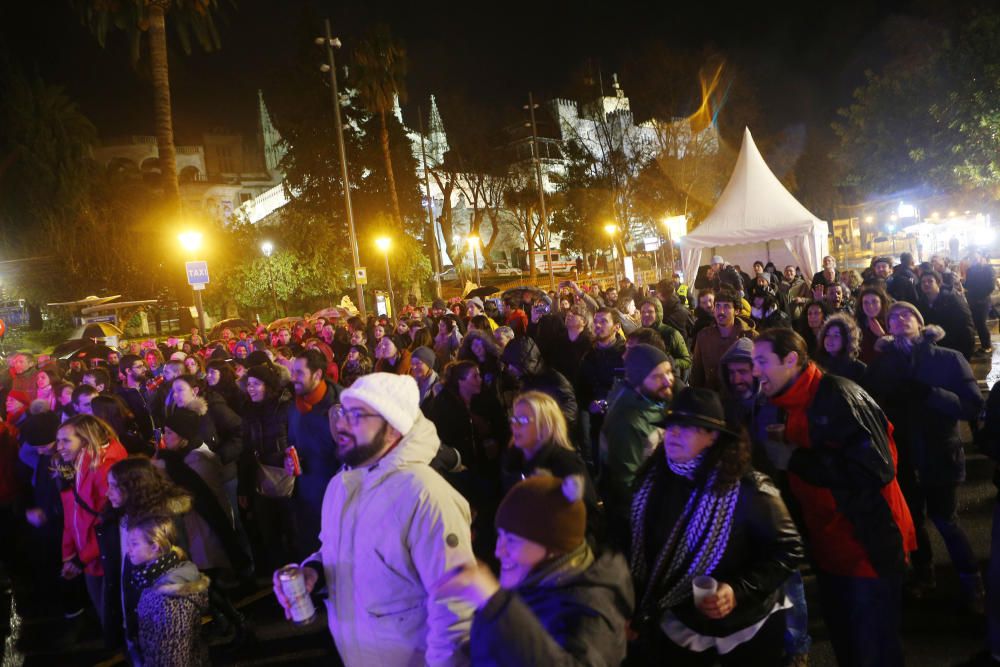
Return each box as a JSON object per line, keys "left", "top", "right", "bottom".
{"left": 630, "top": 459, "right": 740, "bottom": 616}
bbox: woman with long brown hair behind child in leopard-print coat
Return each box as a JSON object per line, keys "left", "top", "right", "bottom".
{"left": 97, "top": 456, "right": 191, "bottom": 648}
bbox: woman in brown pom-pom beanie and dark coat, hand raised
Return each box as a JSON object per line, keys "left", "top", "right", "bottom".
{"left": 435, "top": 475, "right": 634, "bottom": 667}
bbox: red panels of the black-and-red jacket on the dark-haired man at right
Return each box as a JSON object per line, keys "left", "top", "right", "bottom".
{"left": 773, "top": 363, "right": 917, "bottom": 577}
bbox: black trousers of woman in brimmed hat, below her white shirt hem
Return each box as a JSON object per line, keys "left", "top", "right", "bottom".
{"left": 626, "top": 611, "right": 785, "bottom": 667}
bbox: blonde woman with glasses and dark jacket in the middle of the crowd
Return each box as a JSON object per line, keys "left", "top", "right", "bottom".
{"left": 502, "top": 391, "right": 601, "bottom": 541}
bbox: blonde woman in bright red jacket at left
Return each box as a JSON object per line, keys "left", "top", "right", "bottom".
{"left": 56, "top": 415, "right": 128, "bottom": 625}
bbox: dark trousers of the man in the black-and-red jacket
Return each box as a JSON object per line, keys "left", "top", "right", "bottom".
{"left": 816, "top": 571, "right": 903, "bottom": 667}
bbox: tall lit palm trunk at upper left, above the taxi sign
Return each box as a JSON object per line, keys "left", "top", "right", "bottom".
{"left": 149, "top": 0, "right": 181, "bottom": 212}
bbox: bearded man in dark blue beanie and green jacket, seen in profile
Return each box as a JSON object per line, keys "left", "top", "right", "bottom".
{"left": 600, "top": 345, "right": 674, "bottom": 548}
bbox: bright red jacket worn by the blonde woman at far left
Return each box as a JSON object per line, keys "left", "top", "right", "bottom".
{"left": 60, "top": 440, "right": 128, "bottom": 576}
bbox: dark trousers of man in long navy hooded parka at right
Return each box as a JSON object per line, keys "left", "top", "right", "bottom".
{"left": 899, "top": 463, "right": 979, "bottom": 574}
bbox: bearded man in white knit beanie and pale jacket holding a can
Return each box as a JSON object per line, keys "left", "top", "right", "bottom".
{"left": 274, "top": 373, "right": 475, "bottom": 667}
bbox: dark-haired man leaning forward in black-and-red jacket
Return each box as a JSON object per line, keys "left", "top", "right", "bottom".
{"left": 753, "top": 329, "right": 916, "bottom": 667}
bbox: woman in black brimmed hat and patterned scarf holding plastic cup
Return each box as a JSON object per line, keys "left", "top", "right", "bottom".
{"left": 630, "top": 387, "right": 803, "bottom": 667}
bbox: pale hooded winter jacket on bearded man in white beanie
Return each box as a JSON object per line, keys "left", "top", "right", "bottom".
{"left": 307, "top": 415, "right": 474, "bottom": 667}
